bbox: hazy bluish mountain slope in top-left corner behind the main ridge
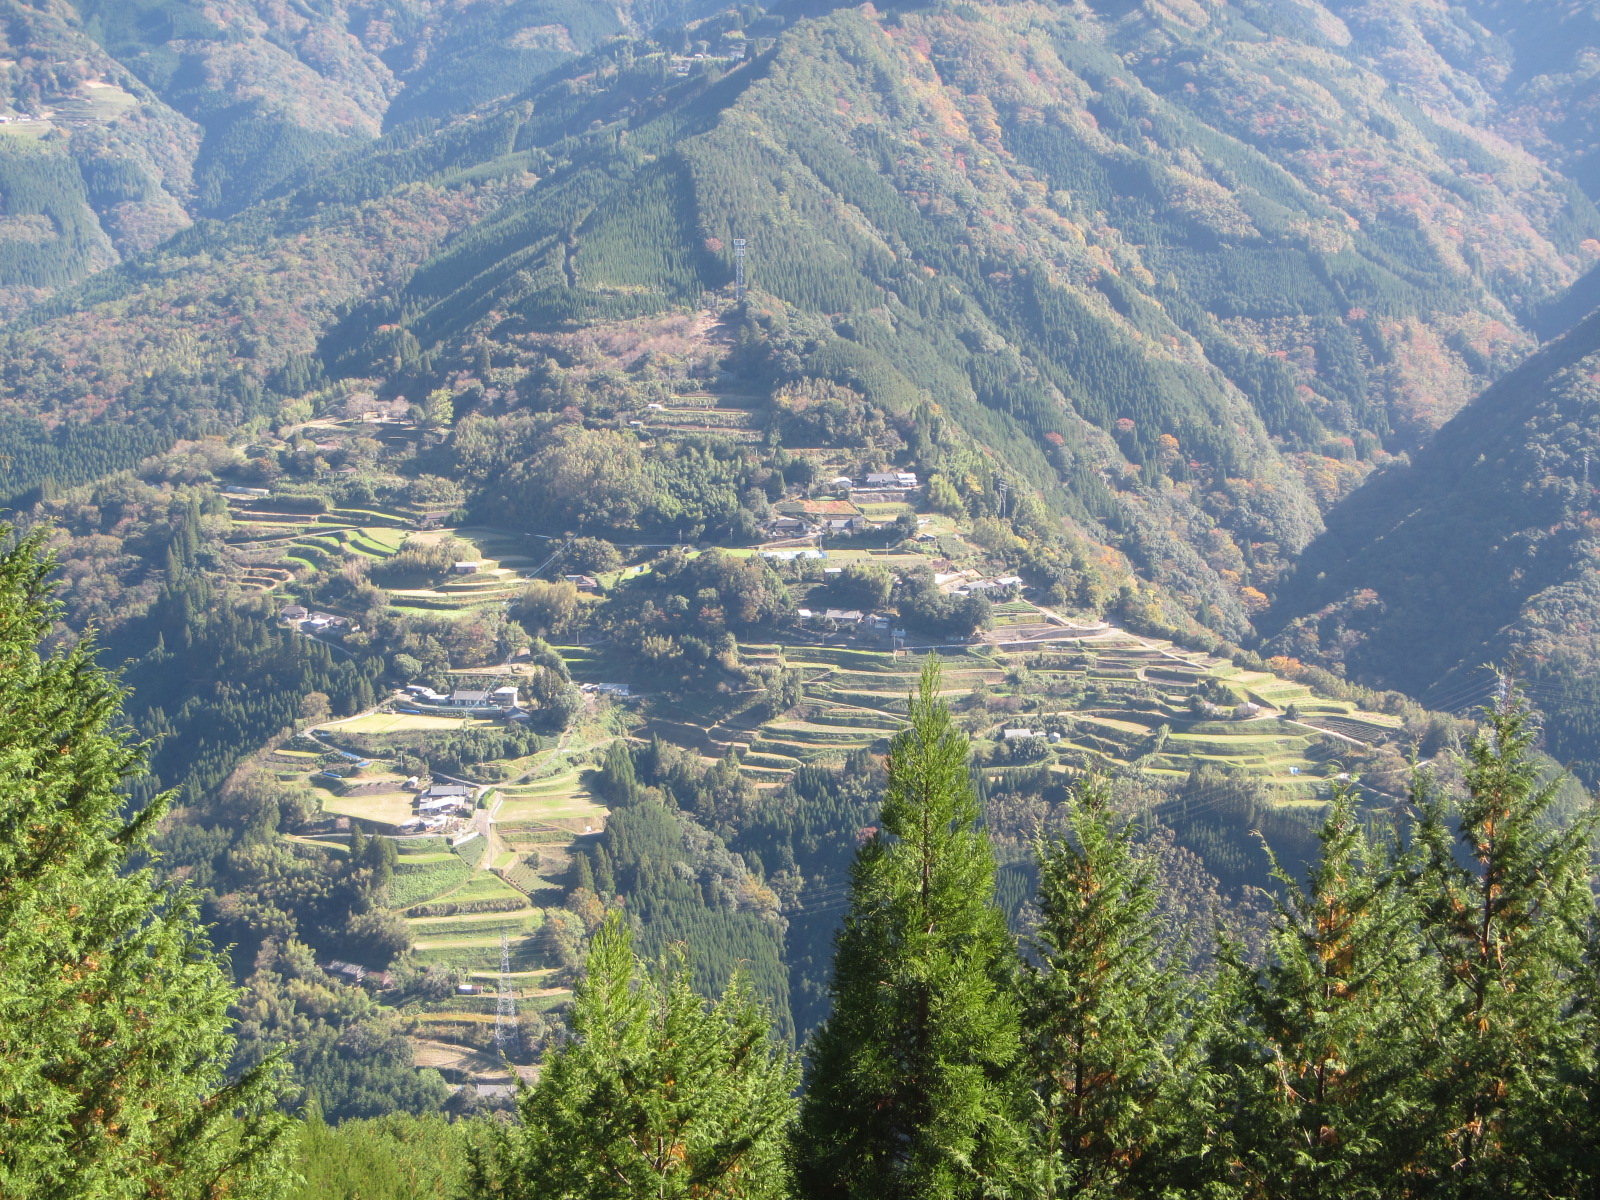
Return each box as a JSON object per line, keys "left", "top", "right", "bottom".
{"left": 0, "top": 0, "right": 713, "bottom": 312}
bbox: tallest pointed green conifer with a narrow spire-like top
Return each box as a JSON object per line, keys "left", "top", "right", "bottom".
{"left": 795, "top": 656, "right": 1021, "bottom": 1200}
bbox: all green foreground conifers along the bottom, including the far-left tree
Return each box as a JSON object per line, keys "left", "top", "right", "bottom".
{"left": 9, "top": 512, "right": 1600, "bottom": 1198}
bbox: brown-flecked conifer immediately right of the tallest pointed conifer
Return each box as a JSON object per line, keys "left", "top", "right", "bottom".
{"left": 1022, "top": 778, "right": 1195, "bottom": 1197}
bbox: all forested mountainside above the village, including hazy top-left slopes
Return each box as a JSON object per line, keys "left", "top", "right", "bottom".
{"left": 0, "top": 0, "right": 1600, "bottom": 739}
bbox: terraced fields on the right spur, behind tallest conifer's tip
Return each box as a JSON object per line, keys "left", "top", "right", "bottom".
{"left": 656, "top": 630, "right": 1400, "bottom": 798}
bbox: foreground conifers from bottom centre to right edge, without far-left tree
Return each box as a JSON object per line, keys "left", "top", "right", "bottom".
{"left": 477, "top": 662, "right": 1600, "bottom": 1197}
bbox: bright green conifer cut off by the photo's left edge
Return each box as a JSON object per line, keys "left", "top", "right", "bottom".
{"left": 0, "top": 530, "right": 283, "bottom": 1200}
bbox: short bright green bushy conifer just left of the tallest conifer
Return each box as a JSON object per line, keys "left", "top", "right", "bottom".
{"left": 474, "top": 912, "right": 798, "bottom": 1200}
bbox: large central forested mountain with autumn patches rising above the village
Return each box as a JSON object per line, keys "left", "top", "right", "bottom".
{"left": 3, "top": 3, "right": 1600, "bottom": 640}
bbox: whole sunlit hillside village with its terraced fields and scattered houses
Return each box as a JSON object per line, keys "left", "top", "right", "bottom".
{"left": 212, "top": 408, "right": 1427, "bottom": 1098}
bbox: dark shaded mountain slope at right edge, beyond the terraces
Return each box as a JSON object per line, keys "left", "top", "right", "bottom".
{"left": 1261, "top": 305, "right": 1600, "bottom": 776}
